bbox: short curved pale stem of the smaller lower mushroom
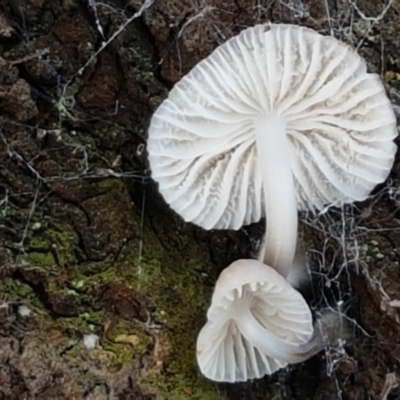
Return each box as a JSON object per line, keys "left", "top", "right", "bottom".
{"left": 235, "top": 303, "right": 327, "bottom": 364}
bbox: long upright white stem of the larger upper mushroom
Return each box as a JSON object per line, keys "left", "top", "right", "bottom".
{"left": 255, "top": 115, "right": 297, "bottom": 277}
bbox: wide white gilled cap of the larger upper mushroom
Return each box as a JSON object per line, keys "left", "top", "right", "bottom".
{"left": 147, "top": 24, "right": 397, "bottom": 229}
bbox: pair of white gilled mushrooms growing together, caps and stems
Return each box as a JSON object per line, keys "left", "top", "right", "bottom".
{"left": 147, "top": 24, "right": 397, "bottom": 382}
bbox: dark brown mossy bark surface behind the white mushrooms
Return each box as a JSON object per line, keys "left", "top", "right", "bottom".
{"left": 0, "top": 0, "right": 400, "bottom": 400}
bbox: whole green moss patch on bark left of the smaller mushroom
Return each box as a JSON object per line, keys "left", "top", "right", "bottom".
{"left": 1, "top": 179, "right": 219, "bottom": 400}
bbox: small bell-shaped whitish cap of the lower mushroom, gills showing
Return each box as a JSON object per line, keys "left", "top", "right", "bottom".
{"left": 197, "top": 260, "right": 314, "bottom": 382}
